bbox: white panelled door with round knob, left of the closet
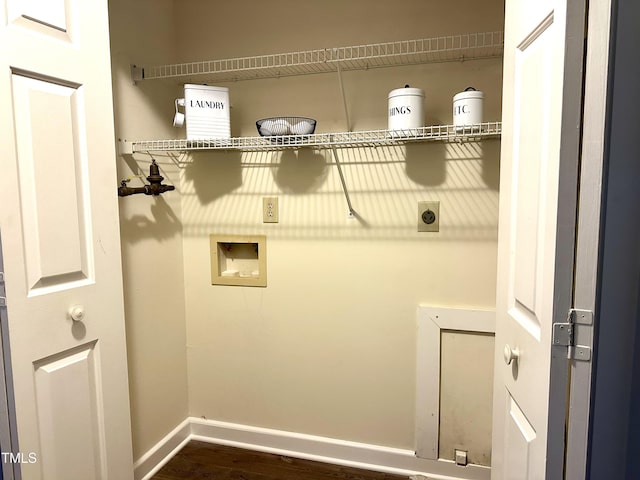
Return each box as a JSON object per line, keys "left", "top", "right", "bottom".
{"left": 0, "top": 0, "right": 133, "bottom": 480}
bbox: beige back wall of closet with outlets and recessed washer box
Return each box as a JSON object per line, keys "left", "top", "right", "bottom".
{"left": 176, "top": 0, "right": 503, "bottom": 449}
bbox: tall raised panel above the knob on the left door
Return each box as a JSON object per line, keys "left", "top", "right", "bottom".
{"left": 12, "top": 75, "right": 93, "bottom": 296}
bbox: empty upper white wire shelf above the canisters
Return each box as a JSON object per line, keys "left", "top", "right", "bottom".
{"left": 140, "top": 32, "right": 504, "bottom": 83}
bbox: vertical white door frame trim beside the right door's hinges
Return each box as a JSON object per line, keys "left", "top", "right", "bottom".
{"left": 565, "top": 0, "right": 612, "bottom": 478}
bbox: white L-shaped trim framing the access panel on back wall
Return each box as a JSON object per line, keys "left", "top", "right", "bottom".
{"left": 416, "top": 306, "right": 496, "bottom": 460}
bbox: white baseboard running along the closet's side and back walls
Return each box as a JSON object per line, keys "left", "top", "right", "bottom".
{"left": 135, "top": 417, "right": 491, "bottom": 480}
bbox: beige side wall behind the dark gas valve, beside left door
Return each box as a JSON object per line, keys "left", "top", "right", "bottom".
{"left": 109, "top": 0, "right": 188, "bottom": 459}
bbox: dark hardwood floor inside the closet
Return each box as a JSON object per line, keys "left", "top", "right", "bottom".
{"left": 151, "top": 441, "right": 407, "bottom": 480}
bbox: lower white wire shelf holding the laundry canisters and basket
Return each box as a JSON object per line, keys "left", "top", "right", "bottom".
{"left": 122, "top": 122, "right": 502, "bottom": 153}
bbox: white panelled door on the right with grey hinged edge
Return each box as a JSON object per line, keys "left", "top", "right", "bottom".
{"left": 492, "top": 0, "right": 585, "bottom": 480}
